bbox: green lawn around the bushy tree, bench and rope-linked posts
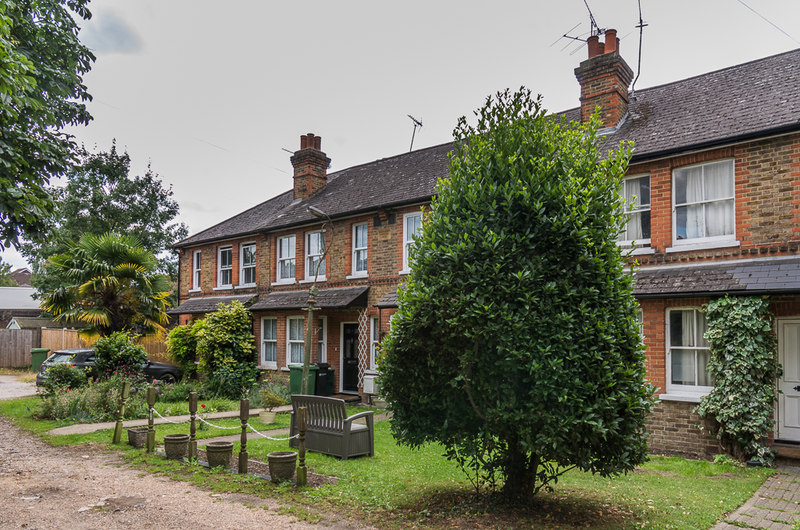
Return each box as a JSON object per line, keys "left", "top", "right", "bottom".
{"left": 0, "top": 398, "right": 773, "bottom": 529}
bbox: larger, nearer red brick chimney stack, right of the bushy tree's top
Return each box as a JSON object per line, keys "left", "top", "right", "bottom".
{"left": 575, "top": 29, "right": 633, "bottom": 127}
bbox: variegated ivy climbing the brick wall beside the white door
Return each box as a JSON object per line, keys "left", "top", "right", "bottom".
{"left": 697, "top": 296, "right": 782, "bottom": 464}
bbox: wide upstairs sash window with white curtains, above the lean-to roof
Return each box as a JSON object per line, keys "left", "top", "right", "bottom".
{"left": 672, "top": 160, "right": 735, "bottom": 244}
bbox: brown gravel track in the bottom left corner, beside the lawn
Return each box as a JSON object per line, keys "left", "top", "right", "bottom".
{"left": 0, "top": 418, "right": 353, "bottom": 530}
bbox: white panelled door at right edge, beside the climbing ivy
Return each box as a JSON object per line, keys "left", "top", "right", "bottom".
{"left": 777, "top": 318, "right": 800, "bottom": 442}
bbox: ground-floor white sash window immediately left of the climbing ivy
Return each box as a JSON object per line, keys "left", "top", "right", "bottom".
{"left": 667, "top": 308, "right": 714, "bottom": 394}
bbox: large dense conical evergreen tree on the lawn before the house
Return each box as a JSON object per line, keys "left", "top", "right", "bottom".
{"left": 380, "top": 90, "right": 652, "bottom": 499}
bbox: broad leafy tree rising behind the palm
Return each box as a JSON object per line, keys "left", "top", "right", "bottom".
{"left": 19, "top": 142, "right": 188, "bottom": 291}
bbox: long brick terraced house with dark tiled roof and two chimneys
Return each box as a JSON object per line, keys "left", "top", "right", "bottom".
{"left": 172, "top": 30, "right": 800, "bottom": 456}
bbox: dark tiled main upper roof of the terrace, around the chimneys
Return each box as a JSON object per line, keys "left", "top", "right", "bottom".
{"left": 174, "top": 49, "right": 800, "bottom": 248}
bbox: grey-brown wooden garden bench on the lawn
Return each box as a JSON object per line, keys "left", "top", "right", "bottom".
{"left": 289, "top": 394, "right": 375, "bottom": 460}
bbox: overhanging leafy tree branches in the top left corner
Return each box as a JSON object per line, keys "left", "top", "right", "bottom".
{"left": 0, "top": 0, "right": 94, "bottom": 248}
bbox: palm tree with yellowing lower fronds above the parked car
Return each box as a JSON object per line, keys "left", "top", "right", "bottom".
{"left": 42, "top": 233, "right": 172, "bottom": 337}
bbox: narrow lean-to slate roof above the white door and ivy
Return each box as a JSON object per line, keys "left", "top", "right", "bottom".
{"left": 634, "top": 257, "right": 800, "bottom": 298}
